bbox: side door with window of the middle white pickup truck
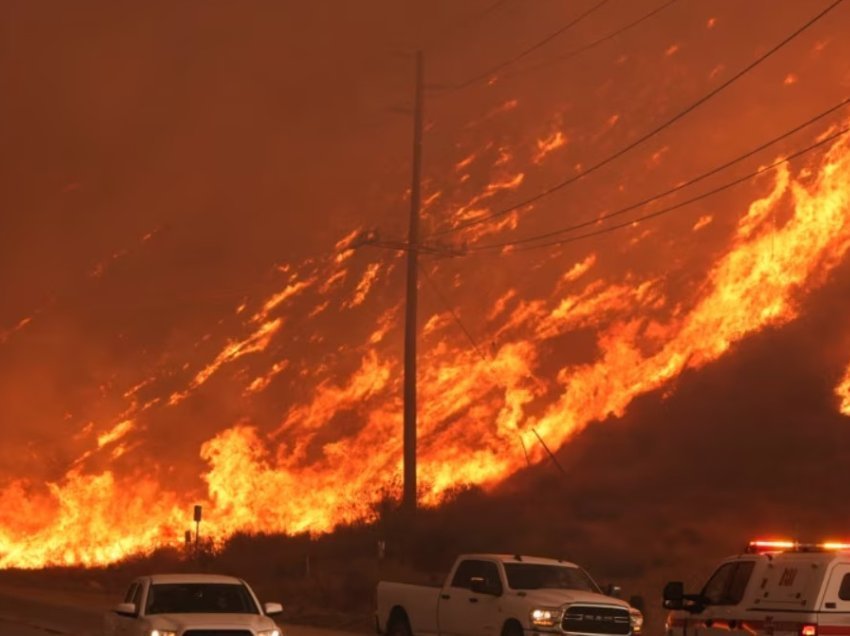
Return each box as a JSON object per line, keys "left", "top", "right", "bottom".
{"left": 437, "top": 559, "right": 502, "bottom": 636}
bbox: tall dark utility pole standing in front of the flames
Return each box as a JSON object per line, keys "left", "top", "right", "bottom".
{"left": 402, "top": 51, "right": 425, "bottom": 513}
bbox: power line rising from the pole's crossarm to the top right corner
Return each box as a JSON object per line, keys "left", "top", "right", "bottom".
{"left": 431, "top": 0, "right": 844, "bottom": 236}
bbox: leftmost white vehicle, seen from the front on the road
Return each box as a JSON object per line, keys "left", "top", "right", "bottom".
{"left": 104, "top": 574, "right": 283, "bottom": 636}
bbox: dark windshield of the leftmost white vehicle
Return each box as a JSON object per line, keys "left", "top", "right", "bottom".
{"left": 145, "top": 583, "right": 260, "bottom": 614}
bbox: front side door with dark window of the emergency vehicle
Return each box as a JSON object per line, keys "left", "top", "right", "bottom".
{"left": 693, "top": 561, "right": 755, "bottom": 636}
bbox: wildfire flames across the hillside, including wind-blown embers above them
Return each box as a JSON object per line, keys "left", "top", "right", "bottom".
{"left": 0, "top": 3, "right": 850, "bottom": 568}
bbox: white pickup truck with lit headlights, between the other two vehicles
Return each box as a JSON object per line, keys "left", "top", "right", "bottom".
{"left": 376, "top": 554, "right": 643, "bottom": 636}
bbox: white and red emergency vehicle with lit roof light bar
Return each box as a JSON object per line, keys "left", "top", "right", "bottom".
{"left": 664, "top": 540, "right": 850, "bottom": 636}
